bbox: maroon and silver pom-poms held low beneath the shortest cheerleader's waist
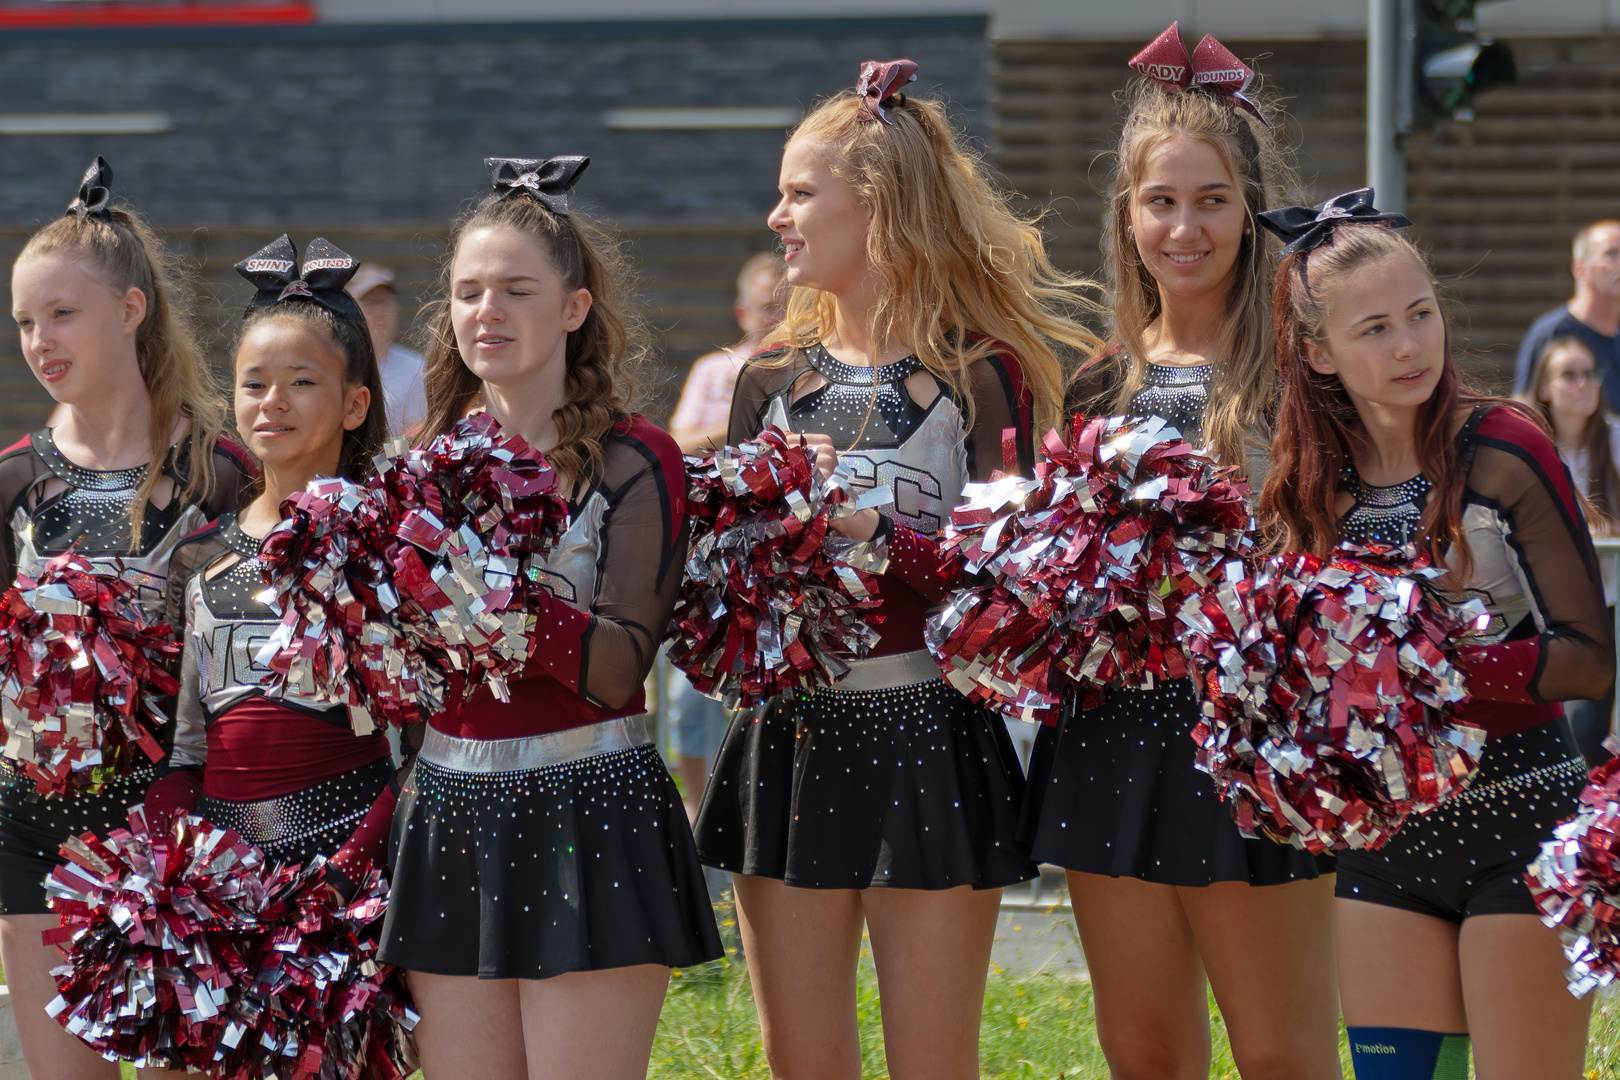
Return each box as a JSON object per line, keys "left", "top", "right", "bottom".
{"left": 45, "top": 808, "right": 416, "bottom": 1080}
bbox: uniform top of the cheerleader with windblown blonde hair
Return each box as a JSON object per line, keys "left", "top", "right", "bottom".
{"left": 727, "top": 345, "right": 1035, "bottom": 656}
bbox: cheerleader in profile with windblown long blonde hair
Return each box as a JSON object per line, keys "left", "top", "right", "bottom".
{"left": 697, "top": 60, "right": 1097, "bottom": 1078}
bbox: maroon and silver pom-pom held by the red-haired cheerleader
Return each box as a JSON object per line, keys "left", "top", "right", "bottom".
{"left": 1181, "top": 544, "right": 1484, "bottom": 853}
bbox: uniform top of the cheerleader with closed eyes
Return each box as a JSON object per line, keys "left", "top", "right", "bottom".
{"left": 431, "top": 416, "right": 687, "bottom": 738}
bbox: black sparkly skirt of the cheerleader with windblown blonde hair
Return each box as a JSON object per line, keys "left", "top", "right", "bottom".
{"left": 695, "top": 678, "right": 1037, "bottom": 889}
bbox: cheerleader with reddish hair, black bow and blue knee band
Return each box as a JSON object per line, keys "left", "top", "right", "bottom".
{"left": 1260, "top": 189, "right": 1615, "bottom": 1080}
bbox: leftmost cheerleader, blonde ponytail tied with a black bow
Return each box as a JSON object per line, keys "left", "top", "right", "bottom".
{"left": 0, "top": 157, "right": 251, "bottom": 1080}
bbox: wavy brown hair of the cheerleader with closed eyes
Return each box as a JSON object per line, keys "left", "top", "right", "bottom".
{"left": 418, "top": 196, "right": 648, "bottom": 483}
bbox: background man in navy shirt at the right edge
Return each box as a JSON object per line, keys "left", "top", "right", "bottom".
{"left": 1513, "top": 220, "right": 1620, "bottom": 413}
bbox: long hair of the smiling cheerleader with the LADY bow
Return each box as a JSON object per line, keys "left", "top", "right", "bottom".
{"left": 1100, "top": 76, "right": 1296, "bottom": 465}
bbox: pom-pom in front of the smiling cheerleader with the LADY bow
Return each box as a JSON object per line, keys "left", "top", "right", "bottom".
{"left": 927, "top": 418, "right": 1254, "bottom": 722}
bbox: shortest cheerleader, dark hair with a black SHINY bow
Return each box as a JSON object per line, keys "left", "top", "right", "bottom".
{"left": 146, "top": 236, "right": 394, "bottom": 889}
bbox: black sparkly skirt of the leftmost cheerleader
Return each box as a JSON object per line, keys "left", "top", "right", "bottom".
{"left": 0, "top": 763, "right": 157, "bottom": 915}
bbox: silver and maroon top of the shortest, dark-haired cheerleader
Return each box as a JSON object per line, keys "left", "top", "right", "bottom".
{"left": 159, "top": 513, "right": 389, "bottom": 801}
